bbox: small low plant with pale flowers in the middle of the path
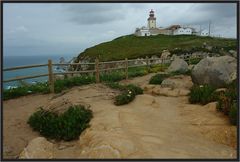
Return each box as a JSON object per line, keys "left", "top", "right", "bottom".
{"left": 106, "top": 82, "right": 143, "bottom": 106}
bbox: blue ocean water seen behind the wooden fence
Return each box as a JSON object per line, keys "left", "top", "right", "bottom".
{"left": 2, "top": 55, "right": 75, "bottom": 89}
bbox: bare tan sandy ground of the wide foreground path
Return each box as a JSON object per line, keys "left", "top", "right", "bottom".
{"left": 3, "top": 74, "right": 237, "bottom": 159}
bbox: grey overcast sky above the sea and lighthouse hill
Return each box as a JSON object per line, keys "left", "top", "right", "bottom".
{"left": 3, "top": 3, "right": 237, "bottom": 56}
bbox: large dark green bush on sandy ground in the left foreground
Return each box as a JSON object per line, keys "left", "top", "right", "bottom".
{"left": 28, "top": 106, "right": 93, "bottom": 141}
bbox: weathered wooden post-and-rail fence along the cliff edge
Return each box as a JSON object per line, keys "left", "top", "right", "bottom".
{"left": 3, "top": 57, "right": 203, "bottom": 93}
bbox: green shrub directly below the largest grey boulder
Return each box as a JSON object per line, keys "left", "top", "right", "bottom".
{"left": 189, "top": 85, "right": 217, "bottom": 105}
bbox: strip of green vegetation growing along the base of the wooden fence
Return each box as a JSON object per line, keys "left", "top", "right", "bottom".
{"left": 3, "top": 65, "right": 168, "bottom": 100}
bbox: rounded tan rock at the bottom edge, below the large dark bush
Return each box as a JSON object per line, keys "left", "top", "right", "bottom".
{"left": 19, "top": 137, "right": 53, "bottom": 159}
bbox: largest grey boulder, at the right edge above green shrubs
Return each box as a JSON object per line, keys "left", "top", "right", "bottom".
{"left": 192, "top": 56, "right": 237, "bottom": 87}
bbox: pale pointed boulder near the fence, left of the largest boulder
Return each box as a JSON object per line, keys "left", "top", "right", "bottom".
{"left": 168, "top": 58, "right": 188, "bottom": 72}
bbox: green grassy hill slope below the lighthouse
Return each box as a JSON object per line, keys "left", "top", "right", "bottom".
{"left": 78, "top": 35, "right": 237, "bottom": 61}
